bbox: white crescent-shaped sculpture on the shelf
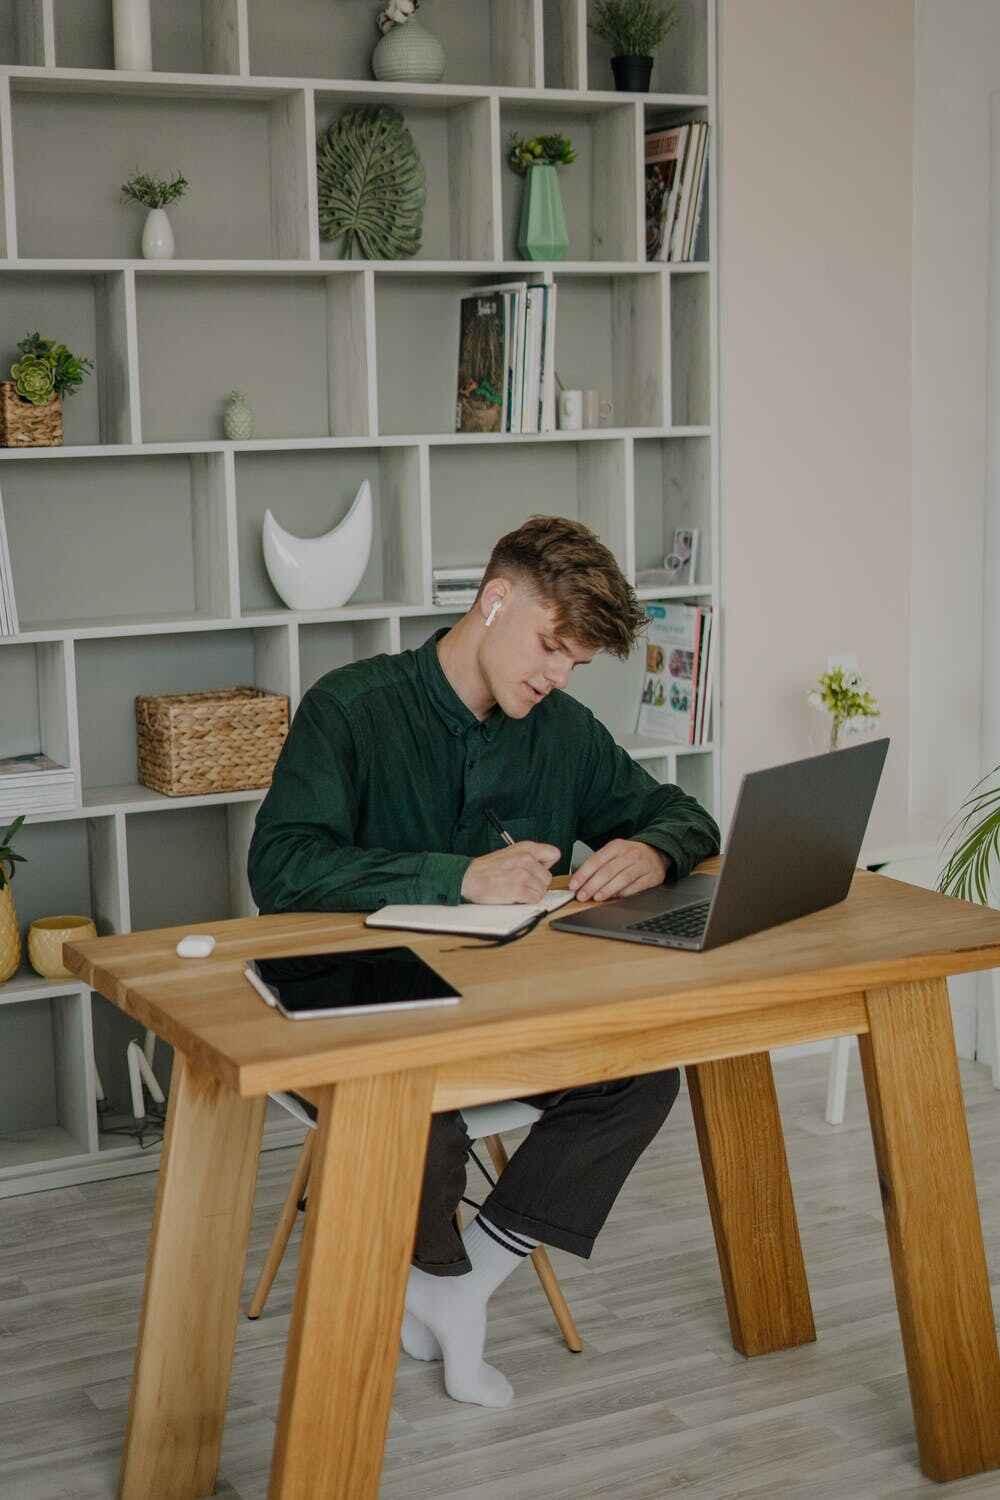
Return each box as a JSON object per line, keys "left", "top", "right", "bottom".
{"left": 264, "top": 480, "right": 372, "bottom": 609}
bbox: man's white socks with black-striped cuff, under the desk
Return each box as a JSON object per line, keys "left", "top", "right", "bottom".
{"left": 403, "top": 1215, "right": 538, "bottom": 1407}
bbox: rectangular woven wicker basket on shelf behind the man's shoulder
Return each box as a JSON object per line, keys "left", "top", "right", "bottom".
{"left": 135, "top": 687, "right": 288, "bottom": 797}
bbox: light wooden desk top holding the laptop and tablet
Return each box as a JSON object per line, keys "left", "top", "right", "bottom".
{"left": 64, "top": 860, "right": 1000, "bottom": 1095}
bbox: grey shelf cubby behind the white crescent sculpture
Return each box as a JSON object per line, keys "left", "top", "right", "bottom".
{"left": 235, "top": 447, "right": 427, "bottom": 615}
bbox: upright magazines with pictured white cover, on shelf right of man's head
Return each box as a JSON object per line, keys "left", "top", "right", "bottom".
{"left": 637, "top": 605, "right": 715, "bottom": 746}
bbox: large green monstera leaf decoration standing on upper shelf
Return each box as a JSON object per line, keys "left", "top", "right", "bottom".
{"left": 316, "top": 105, "right": 426, "bottom": 261}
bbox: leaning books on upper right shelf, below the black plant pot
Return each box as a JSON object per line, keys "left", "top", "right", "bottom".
{"left": 646, "top": 120, "right": 708, "bottom": 261}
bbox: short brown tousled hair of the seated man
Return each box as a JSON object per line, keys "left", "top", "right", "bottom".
{"left": 480, "top": 516, "right": 646, "bottom": 657}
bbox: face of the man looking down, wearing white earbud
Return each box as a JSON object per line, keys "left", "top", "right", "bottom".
{"left": 475, "top": 579, "right": 597, "bottom": 719}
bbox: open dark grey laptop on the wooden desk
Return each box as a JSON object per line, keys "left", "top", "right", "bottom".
{"left": 550, "top": 740, "right": 889, "bottom": 953}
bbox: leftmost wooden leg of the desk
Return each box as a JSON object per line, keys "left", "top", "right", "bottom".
{"left": 118, "top": 1053, "right": 267, "bottom": 1500}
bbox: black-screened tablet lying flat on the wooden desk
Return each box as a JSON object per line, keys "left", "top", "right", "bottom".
{"left": 243, "top": 947, "right": 462, "bottom": 1022}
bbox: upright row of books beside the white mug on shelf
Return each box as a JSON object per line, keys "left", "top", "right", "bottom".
{"left": 454, "top": 282, "right": 558, "bottom": 432}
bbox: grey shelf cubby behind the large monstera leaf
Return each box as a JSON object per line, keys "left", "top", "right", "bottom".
{"left": 315, "top": 90, "right": 498, "bottom": 261}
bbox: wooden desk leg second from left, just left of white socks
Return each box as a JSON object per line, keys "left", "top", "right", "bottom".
{"left": 268, "top": 1071, "right": 433, "bottom": 1500}
